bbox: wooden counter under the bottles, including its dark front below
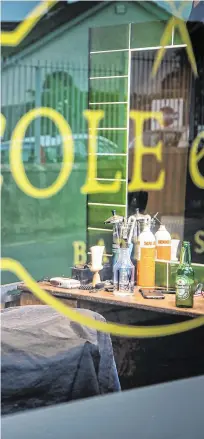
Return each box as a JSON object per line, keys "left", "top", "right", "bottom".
{"left": 18, "top": 282, "right": 204, "bottom": 390}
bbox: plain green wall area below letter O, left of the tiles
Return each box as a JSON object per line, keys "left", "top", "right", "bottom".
{"left": 1, "top": 165, "right": 86, "bottom": 284}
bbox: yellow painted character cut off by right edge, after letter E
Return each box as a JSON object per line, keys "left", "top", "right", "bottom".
{"left": 189, "top": 131, "right": 204, "bottom": 189}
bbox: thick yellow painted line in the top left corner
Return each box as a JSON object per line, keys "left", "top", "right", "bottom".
{"left": 1, "top": 0, "right": 59, "bottom": 46}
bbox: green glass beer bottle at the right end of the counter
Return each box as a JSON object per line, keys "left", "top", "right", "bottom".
{"left": 176, "top": 241, "right": 195, "bottom": 308}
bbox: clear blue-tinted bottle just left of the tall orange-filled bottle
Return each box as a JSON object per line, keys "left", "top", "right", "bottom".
{"left": 113, "top": 239, "right": 135, "bottom": 296}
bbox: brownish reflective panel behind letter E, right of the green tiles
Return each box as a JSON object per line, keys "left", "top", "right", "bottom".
{"left": 129, "top": 49, "right": 192, "bottom": 249}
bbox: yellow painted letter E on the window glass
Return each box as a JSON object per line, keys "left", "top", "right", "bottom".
{"left": 128, "top": 111, "right": 165, "bottom": 192}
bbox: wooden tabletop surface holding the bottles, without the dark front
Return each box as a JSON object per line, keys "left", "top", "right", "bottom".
{"left": 18, "top": 282, "right": 204, "bottom": 317}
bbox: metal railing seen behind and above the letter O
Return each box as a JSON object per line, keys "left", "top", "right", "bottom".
{"left": 2, "top": 63, "right": 88, "bottom": 141}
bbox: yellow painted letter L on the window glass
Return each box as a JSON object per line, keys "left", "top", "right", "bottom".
{"left": 81, "top": 110, "right": 122, "bottom": 194}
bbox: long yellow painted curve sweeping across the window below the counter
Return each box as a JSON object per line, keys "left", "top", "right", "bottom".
{"left": 1, "top": 258, "right": 204, "bottom": 337}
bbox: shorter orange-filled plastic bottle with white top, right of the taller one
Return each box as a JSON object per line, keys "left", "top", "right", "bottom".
{"left": 155, "top": 225, "right": 171, "bottom": 261}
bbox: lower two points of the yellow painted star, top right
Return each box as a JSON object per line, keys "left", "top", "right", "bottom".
{"left": 152, "top": 17, "right": 198, "bottom": 76}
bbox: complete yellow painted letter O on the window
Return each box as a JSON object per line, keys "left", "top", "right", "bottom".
{"left": 9, "top": 107, "right": 74, "bottom": 198}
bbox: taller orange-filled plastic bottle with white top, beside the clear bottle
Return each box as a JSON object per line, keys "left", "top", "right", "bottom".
{"left": 137, "top": 224, "right": 156, "bottom": 288}
